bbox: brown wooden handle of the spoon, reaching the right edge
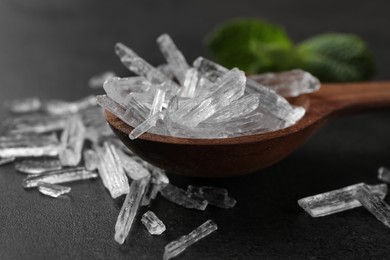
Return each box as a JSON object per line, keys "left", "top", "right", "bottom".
{"left": 310, "top": 81, "right": 390, "bottom": 115}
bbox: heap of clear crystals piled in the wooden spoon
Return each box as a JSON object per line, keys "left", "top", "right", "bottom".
{"left": 97, "top": 34, "right": 320, "bottom": 139}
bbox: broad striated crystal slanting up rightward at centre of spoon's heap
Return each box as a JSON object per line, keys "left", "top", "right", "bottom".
{"left": 172, "top": 69, "right": 246, "bottom": 127}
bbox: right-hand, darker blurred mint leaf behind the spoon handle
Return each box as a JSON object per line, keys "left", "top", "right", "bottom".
{"left": 297, "top": 33, "right": 375, "bottom": 82}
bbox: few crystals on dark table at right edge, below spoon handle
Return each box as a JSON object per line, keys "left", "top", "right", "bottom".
{"left": 298, "top": 167, "right": 390, "bottom": 228}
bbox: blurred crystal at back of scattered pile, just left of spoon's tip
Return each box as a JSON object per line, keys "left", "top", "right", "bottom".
{"left": 43, "top": 96, "right": 96, "bottom": 115}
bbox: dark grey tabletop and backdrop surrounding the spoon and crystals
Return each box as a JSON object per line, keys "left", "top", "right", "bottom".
{"left": 0, "top": 0, "right": 390, "bottom": 259}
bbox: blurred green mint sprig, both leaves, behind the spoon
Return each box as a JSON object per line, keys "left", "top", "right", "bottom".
{"left": 206, "top": 19, "right": 375, "bottom": 82}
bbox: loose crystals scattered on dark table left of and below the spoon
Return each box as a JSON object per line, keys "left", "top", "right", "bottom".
{"left": 0, "top": 91, "right": 236, "bottom": 259}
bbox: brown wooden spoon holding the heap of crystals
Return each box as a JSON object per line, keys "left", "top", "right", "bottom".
{"left": 105, "top": 82, "right": 390, "bottom": 177}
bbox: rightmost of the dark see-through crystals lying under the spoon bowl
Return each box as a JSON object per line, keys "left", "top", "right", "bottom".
{"left": 187, "top": 185, "right": 237, "bottom": 209}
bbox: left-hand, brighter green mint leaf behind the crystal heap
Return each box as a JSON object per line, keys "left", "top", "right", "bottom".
{"left": 206, "top": 19, "right": 295, "bottom": 73}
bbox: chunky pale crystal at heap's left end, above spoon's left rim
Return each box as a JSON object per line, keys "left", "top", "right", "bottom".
{"left": 103, "top": 77, "right": 152, "bottom": 106}
